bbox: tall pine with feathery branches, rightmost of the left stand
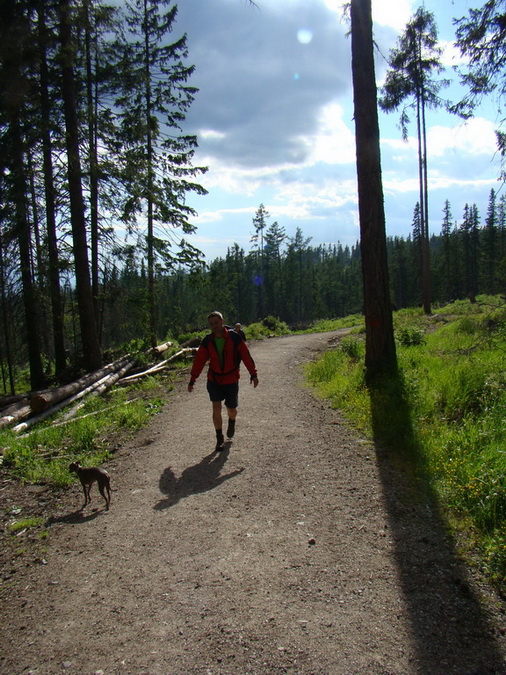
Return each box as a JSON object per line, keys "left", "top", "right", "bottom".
{"left": 116, "top": 0, "right": 206, "bottom": 346}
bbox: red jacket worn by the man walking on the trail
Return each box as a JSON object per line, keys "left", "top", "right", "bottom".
{"left": 190, "top": 328, "right": 257, "bottom": 384}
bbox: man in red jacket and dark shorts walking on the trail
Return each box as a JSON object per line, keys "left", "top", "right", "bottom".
{"left": 188, "top": 312, "right": 258, "bottom": 452}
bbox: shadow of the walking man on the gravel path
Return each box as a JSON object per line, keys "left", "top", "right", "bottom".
{"left": 154, "top": 443, "right": 244, "bottom": 511}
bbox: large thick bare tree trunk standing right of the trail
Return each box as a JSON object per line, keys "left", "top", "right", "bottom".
{"left": 351, "top": 0, "right": 397, "bottom": 382}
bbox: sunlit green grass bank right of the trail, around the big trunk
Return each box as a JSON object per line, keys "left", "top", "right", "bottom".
{"left": 307, "top": 297, "right": 506, "bottom": 588}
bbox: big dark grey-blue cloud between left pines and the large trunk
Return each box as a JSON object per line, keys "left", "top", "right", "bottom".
{"left": 178, "top": 0, "right": 351, "bottom": 169}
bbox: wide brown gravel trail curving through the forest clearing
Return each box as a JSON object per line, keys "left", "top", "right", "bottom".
{"left": 0, "top": 333, "right": 506, "bottom": 675}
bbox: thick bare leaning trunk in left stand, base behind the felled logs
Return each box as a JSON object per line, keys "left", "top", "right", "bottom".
{"left": 59, "top": 0, "right": 102, "bottom": 370}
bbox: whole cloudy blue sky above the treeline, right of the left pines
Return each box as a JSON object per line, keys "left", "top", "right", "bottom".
{"left": 175, "top": 0, "right": 499, "bottom": 261}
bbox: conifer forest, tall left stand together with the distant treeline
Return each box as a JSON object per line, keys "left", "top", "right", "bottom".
{"left": 0, "top": 0, "right": 506, "bottom": 394}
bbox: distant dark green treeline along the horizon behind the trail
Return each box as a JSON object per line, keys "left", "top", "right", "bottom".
{"left": 100, "top": 190, "right": 506, "bottom": 345}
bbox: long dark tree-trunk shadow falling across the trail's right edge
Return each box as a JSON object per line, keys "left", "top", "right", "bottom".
{"left": 370, "top": 378, "right": 506, "bottom": 675}
